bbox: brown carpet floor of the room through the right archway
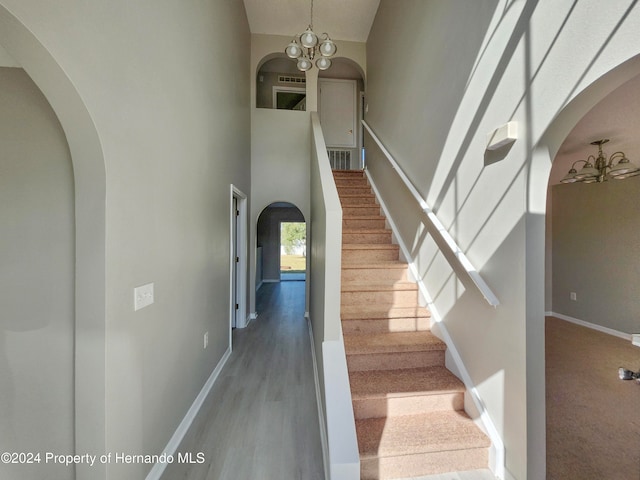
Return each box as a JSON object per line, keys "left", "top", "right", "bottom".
{"left": 546, "top": 317, "right": 640, "bottom": 480}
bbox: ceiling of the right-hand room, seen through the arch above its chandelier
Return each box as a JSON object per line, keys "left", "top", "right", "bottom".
{"left": 549, "top": 76, "right": 640, "bottom": 185}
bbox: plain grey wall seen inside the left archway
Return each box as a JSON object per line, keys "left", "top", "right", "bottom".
{"left": 0, "top": 68, "right": 75, "bottom": 480}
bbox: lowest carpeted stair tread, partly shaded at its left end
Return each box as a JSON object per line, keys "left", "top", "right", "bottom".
{"left": 356, "top": 411, "right": 490, "bottom": 460}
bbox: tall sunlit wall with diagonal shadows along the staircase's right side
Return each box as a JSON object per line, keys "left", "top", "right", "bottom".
{"left": 365, "top": 0, "right": 640, "bottom": 479}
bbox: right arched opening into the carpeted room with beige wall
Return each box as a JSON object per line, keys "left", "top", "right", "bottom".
{"left": 546, "top": 69, "right": 640, "bottom": 478}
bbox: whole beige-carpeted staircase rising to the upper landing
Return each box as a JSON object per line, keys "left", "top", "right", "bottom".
{"left": 333, "top": 170, "right": 490, "bottom": 479}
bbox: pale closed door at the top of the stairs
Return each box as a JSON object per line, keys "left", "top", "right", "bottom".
{"left": 319, "top": 78, "right": 358, "bottom": 148}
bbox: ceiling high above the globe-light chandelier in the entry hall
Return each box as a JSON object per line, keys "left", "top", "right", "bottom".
{"left": 244, "top": 0, "right": 380, "bottom": 42}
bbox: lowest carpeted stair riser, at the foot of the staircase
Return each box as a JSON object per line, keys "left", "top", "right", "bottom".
{"left": 360, "top": 448, "right": 489, "bottom": 480}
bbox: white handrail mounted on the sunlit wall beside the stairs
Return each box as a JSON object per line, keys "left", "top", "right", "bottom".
{"left": 361, "top": 120, "right": 500, "bottom": 307}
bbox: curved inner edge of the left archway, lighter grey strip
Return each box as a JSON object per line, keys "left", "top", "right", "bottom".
{"left": 0, "top": 5, "right": 106, "bottom": 479}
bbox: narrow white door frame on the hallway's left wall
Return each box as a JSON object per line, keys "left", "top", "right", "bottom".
{"left": 229, "top": 184, "right": 247, "bottom": 349}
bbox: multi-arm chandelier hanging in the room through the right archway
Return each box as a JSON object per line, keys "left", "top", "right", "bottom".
{"left": 560, "top": 138, "right": 640, "bottom": 183}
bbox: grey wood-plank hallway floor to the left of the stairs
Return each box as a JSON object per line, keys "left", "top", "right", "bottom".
{"left": 163, "top": 282, "right": 324, "bottom": 480}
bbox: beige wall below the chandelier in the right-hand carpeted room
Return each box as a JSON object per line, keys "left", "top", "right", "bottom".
{"left": 552, "top": 177, "right": 640, "bottom": 334}
